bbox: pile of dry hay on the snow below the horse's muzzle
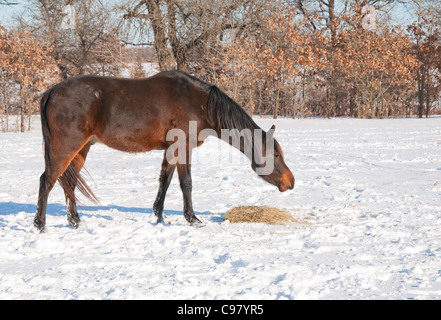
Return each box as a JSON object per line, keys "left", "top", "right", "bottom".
{"left": 224, "top": 206, "right": 295, "bottom": 224}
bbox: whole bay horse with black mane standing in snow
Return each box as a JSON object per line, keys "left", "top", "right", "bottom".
{"left": 34, "top": 71, "right": 294, "bottom": 232}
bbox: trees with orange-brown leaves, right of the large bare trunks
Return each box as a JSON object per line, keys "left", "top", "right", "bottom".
{"left": 190, "top": 1, "right": 441, "bottom": 118}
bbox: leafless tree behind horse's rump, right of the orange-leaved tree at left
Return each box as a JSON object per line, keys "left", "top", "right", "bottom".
{"left": 17, "top": 0, "right": 123, "bottom": 78}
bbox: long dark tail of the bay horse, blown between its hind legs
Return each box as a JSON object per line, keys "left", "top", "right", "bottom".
{"left": 40, "top": 88, "right": 101, "bottom": 206}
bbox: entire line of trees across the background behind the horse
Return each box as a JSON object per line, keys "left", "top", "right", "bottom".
{"left": 0, "top": 0, "right": 441, "bottom": 131}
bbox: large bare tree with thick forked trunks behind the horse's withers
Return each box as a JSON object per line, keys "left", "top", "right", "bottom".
{"left": 120, "top": 0, "right": 270, "bottom": 70}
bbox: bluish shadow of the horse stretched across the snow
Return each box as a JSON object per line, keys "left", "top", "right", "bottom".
{"left": 0, "top": 202, "right": 223, "bottom": 226}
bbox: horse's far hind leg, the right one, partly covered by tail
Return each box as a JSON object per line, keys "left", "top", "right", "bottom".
{"left": 62, "top": 142, "right": 91, "bottom": 228}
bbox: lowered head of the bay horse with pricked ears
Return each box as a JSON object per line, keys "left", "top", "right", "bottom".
{"left": 251, "top": 125, "right": 294, "bottom": 192}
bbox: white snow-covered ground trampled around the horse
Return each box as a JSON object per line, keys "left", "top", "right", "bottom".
{"left": 0, "top": 118, "right": 441, "bottom": 299}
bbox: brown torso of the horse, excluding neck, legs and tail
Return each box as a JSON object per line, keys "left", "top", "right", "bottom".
{"left": 48, "top": 71, "right": 211, "bottom": 152}
